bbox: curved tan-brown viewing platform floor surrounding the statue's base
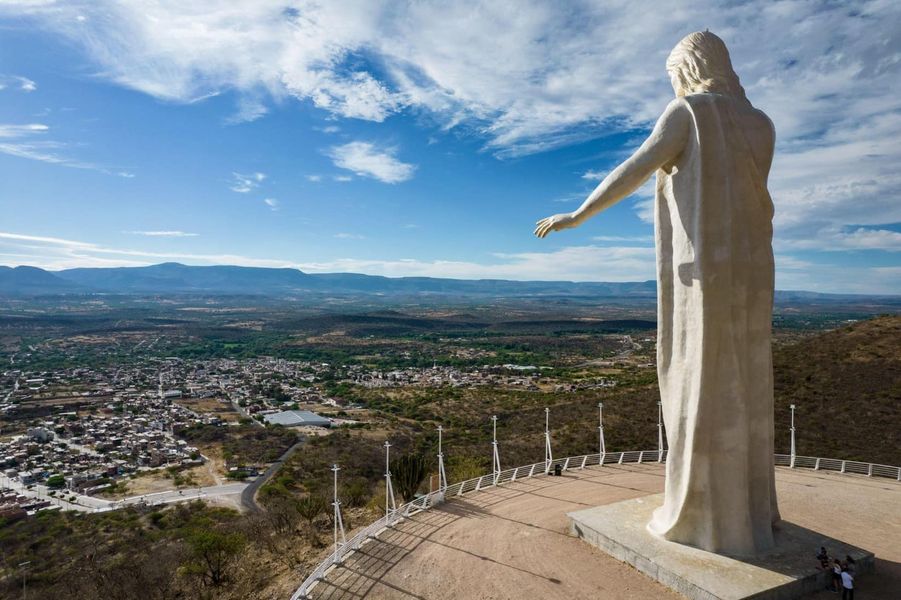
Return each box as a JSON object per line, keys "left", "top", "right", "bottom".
{"left": 310, "top": 463, "right": 901, "bottom": 600}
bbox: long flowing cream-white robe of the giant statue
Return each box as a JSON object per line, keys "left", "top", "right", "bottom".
{"left": 648, "top": 93, "right": 779, "bottom": 555}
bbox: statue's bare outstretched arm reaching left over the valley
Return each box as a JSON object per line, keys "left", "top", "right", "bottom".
{"left": 535, "top": 99, "right": 691, "bottom": 237}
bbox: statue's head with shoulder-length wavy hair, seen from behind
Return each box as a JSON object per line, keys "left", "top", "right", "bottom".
{"left": 666, "top": 31, "right": 747, "bottom": 100}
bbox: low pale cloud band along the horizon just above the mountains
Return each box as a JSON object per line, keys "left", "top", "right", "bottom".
{"left": 0, "top": 232, "right": 901, "bottom": 294}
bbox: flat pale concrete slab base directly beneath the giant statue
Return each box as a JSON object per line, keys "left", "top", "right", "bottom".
{"left": 567, "top": 494, "right": 874, "bottom": 600}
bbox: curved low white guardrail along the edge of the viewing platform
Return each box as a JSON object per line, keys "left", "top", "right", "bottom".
{"left": 291, "top": 450, "right": 901, "bottom": 600}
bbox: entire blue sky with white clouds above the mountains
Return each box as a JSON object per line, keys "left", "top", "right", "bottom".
{"left": 0, "top": 0, "right": 901, "bottom": 293}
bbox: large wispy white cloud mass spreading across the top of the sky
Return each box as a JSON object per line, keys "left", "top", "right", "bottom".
{"left": 0, "top": 0, "right": 901, "bottom": 258}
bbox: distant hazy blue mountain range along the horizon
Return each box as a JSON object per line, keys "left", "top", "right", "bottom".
{"left": 0, "top": 263, "right": 896, "bottom": 301}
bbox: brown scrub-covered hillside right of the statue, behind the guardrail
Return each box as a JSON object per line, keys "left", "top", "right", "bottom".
{"left": 773, "top": 315, "right": 901, "bottom": 465}
